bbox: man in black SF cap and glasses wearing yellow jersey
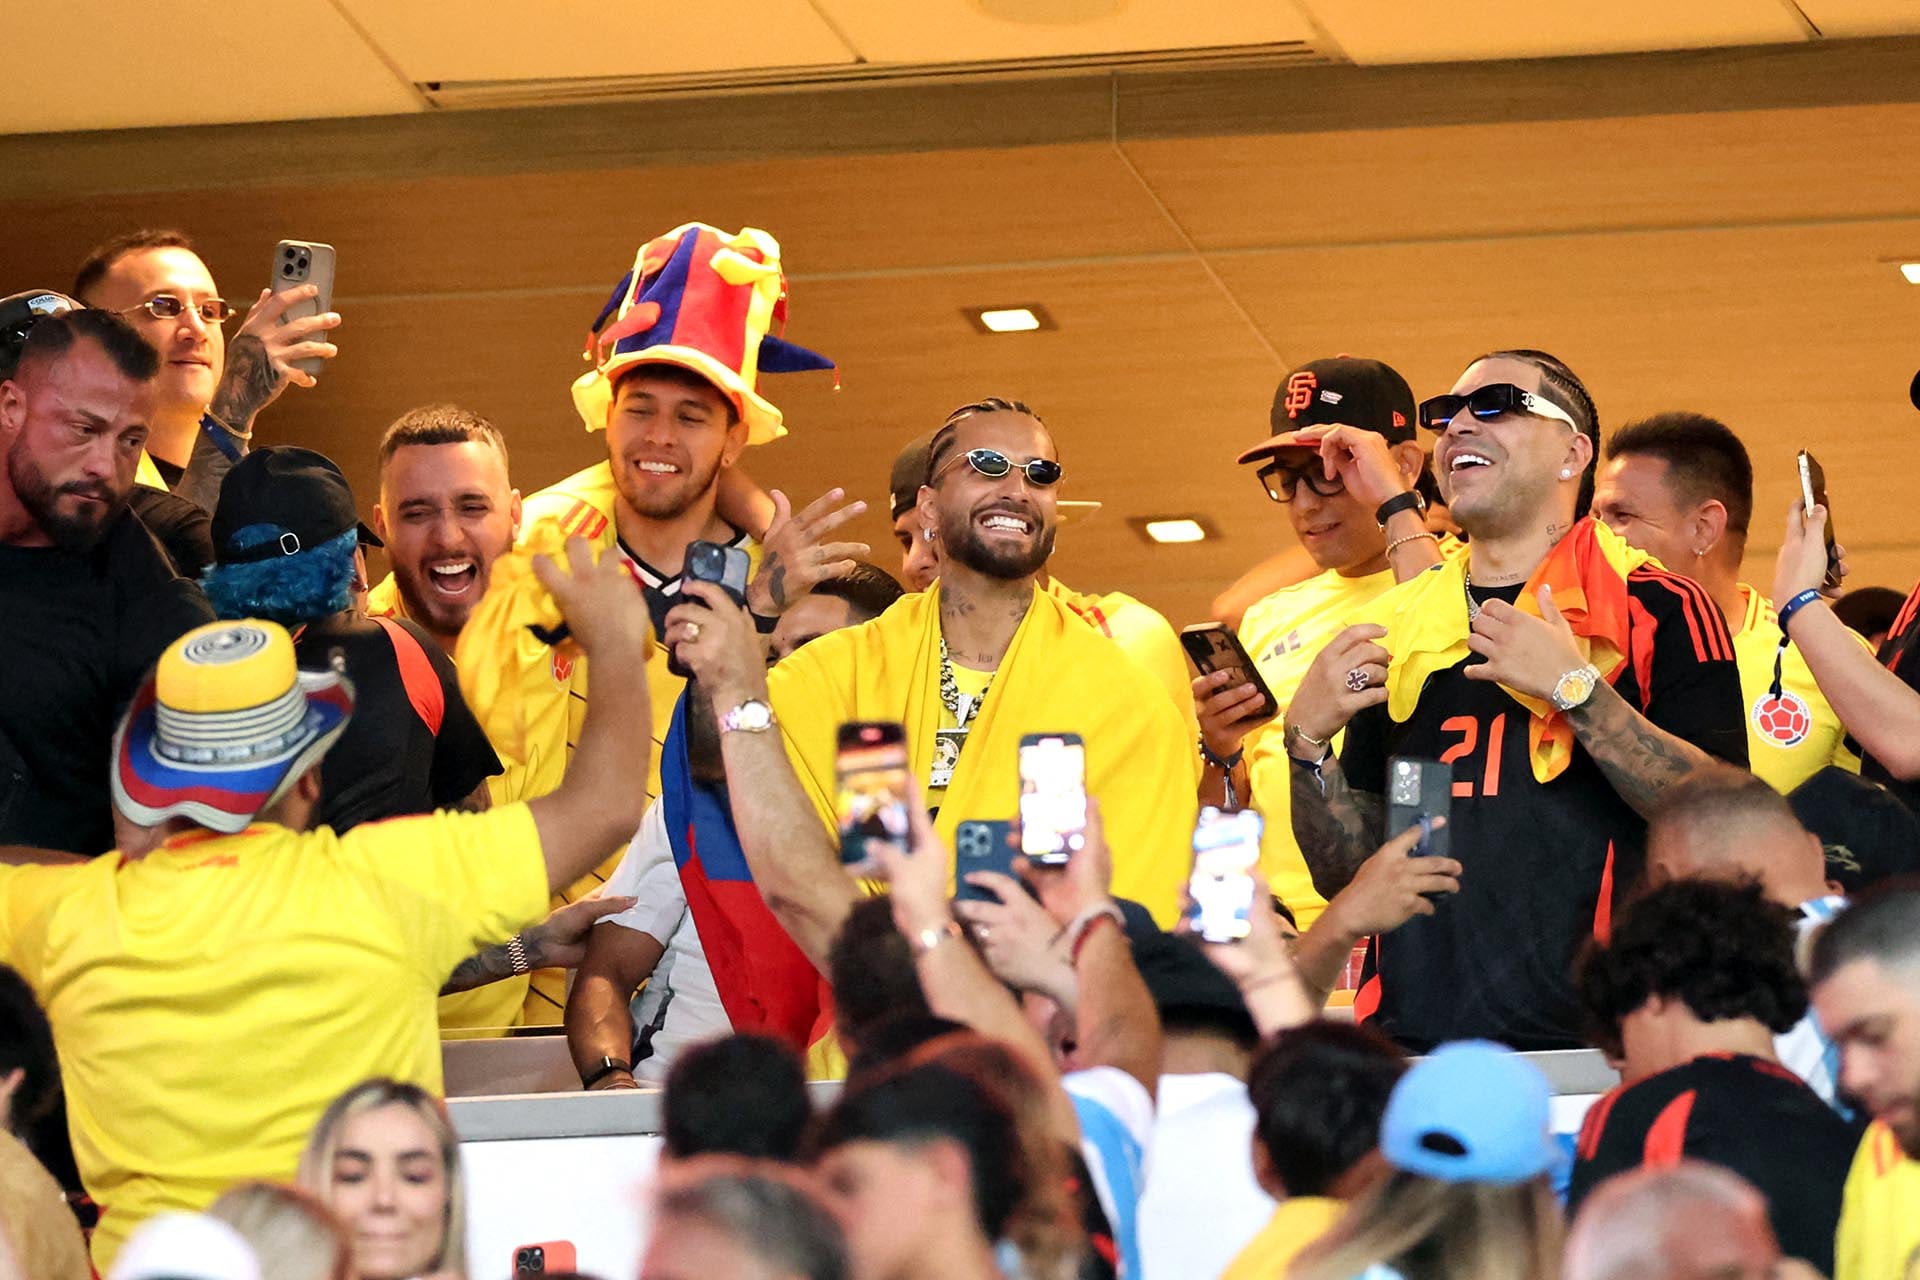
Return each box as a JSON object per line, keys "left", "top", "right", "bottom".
{"left": 1192, "top": 355, "right": 1440, "bottom": 929}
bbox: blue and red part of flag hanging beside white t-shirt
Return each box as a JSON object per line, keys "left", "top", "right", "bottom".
{"left": 660, "top": 699, "right": 820, "bottom": 1052}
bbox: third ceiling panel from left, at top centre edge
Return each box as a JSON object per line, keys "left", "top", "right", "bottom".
{"left": 818, "top": 0, "right": 1315, "bottom": 63}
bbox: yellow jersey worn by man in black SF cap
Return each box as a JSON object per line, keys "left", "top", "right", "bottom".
{"left": 1240, "top": 570, "right": 1394, "bottom": 929}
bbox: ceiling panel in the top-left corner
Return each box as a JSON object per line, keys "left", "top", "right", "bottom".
{"left": 0, "top": 0, "right": 420, "bottom": 134}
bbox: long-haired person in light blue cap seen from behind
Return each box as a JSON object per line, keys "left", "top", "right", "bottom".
{"left": 1286, "top": 1040, "right": 1565, "bottom": 1280}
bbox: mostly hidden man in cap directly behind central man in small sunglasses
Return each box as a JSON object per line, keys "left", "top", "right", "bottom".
{"left": 887, "top": 416, "right": 1200, "bottom": 744}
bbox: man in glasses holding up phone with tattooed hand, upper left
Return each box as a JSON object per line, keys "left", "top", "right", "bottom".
{"left": 73, "top": 230, "right": 340, "bottom": 510}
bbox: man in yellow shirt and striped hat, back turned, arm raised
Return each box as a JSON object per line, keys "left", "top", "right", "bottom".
{"left": 0, "top": 541, "right": 653, "bottom": 1274}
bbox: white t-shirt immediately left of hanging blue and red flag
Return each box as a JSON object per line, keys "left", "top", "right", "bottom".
{"left": 605, "top": 800, "right": 733, "bottom": 1084}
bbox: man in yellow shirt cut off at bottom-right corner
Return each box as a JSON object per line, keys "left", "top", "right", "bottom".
{"left": 1807, "top": 879, "right": 1920, "bottom": 1280}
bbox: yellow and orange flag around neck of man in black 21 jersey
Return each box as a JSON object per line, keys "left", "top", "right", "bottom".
{"left": 1354, "top": 516, "right": 1653, "bottom": 783}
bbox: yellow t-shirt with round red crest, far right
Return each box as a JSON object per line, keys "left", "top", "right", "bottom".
{"left": 1728, "top": 583, "right": 1872, "bottom": 794}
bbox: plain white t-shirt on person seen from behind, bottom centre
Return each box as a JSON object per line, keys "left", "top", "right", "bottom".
{"left": 1140, "top": 1071, "right": 1275, "bottom": 1280}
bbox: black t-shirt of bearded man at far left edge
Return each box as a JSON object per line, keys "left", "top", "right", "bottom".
{"left": 0, "top": 512, "right": 213, "bottom": 854}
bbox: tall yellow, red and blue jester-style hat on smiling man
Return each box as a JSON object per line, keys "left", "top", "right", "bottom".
{"left": 574, "top": 223, "right": 833, "bottom": 445}
